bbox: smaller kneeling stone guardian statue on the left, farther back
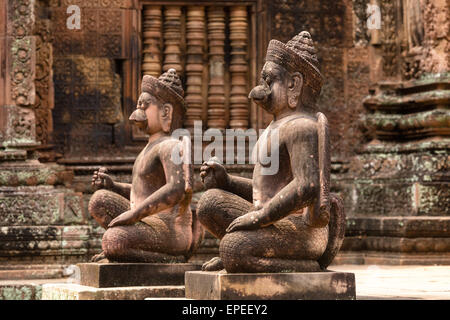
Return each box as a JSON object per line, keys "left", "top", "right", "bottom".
{"left": 89, "top": 69, "right": 203, "bottom": 263}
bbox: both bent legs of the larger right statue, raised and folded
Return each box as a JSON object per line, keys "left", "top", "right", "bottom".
{"left": 197, "top": 189, "right": 336, "bottom": 272}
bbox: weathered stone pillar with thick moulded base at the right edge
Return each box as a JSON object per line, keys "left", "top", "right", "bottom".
{"left": 340, "top": 0, "right": 450, "bottom": 264}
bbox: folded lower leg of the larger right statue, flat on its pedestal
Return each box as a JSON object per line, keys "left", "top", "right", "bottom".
{"left": 219, "top": 214, "right": 328, "bottom": 273}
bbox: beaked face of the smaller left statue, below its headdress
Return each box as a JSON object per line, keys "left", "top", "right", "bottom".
{"left": 129, "top": 92, "right": 162, "bottom": 134}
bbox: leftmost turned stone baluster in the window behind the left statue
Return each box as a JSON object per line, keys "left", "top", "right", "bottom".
{"left": 142, "top": 6, "right": 162, "bottom": 77}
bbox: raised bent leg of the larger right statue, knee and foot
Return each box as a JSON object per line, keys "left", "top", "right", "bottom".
{"left": 197, "top": 189, "right": 252, "bottom": 271}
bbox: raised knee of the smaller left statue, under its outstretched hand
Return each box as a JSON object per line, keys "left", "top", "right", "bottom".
{"left": 88, "top": 189, "right": 130, "bottom": 229}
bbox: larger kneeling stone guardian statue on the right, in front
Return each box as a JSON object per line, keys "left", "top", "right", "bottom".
{"left": 197, "top": 31, "right": 345, "bottom": 273}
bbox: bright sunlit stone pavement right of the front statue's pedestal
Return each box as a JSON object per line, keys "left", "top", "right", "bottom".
{"left": 328, "top": 265, "right": 450, "bottom": 300}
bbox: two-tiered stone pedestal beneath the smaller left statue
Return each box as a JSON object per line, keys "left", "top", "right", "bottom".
{"left": 42, "top": 263, "right": 201, "bottom": 300}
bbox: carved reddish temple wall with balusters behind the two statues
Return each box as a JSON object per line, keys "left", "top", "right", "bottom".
{"left": 0, "top": 0, "right": 450, "bottom": 274}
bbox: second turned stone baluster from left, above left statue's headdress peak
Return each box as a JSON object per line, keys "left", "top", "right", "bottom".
{"left": 163, "top": 6, "right": 183, "bottom": 74}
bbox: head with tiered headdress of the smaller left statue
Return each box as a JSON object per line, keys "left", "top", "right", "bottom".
{"left": 129, "top": 69, "right": 186, "bottom": 135}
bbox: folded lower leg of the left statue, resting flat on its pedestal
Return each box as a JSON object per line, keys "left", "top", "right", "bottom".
{"left": 102, "top": 222, "right": 186, "bottom": 263}
